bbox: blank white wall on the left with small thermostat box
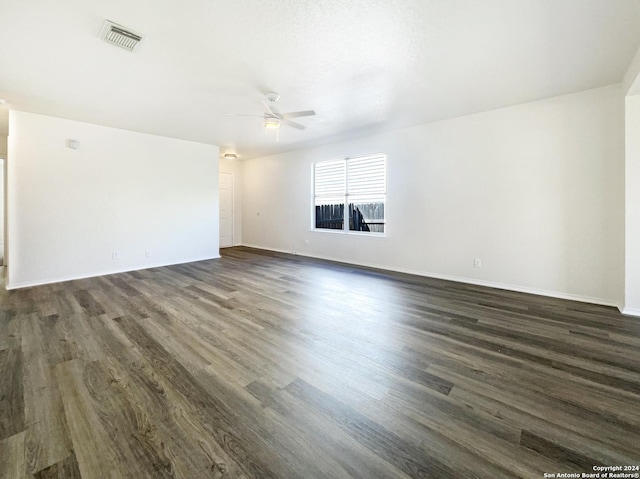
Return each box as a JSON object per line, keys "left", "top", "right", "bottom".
{"left": 7, "top": 111, "right": 219, "bottom": 288}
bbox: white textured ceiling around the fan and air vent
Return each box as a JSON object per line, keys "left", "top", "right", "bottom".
{"left": 0, "top": 0, "right": 640, "bottom": 158}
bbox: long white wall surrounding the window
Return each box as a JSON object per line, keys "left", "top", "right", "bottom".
{"left": 242, "top": 85, "right": 624, "bottom": 305}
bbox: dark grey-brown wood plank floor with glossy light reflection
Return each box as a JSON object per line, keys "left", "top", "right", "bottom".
{"left": 0, "top": 248, "right": 640, "bottom": 479}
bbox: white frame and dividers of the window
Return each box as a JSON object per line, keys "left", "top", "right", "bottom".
{"left": 310, "top": 153, "right": 389, "bottom": 238}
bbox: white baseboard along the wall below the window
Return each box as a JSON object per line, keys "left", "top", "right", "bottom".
{"left": 242, "top": 244, "right": 616, "bottom": 308}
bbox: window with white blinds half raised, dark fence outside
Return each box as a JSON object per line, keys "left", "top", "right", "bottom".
{"left": 313, "top": 155, "right": 387, "bottom": 233}
